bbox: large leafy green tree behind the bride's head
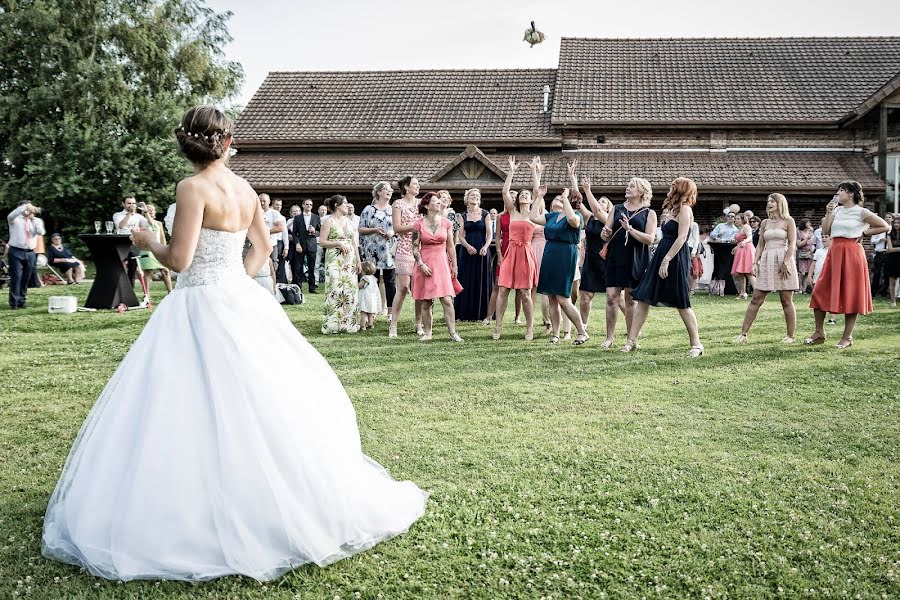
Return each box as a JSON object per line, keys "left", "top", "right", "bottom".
{"left": 0, "top": 0, "right": 243, "bottom": 239}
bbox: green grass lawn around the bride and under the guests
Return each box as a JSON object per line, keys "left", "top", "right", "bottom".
{"left": 0, "top": 284, "right": 900, "bottom": 598}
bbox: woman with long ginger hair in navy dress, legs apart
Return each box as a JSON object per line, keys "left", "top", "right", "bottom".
{"left": 628, "top": 177, "right": 703, "bottom": 358}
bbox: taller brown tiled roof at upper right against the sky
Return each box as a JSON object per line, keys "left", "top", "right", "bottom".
{"left": 553, "top": 36, "right": 900, "bottom": 125}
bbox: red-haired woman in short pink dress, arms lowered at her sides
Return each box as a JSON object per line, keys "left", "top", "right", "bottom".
{"left": 412, "top": 192, "right": 463, "bottom": 342}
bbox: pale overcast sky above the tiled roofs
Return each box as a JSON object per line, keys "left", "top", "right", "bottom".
{"left": 207, "top": 0, "right": 900, "bottom": 105}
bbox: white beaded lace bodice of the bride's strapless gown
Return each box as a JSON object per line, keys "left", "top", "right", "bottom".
{"left": 176, "top": 228, "right": 247, "bottom": 288}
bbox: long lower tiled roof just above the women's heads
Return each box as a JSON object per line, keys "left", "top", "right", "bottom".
{"left": 231, "top": 151, "right": 884, "bottom": 191}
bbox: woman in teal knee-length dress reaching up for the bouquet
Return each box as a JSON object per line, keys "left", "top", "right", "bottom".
{"left": 530, "top": 161, "right": 588, "bottom": 346}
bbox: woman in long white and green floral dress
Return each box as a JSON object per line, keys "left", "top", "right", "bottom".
{"left": 319, "top": 194, "right": 362, "bottom": 333}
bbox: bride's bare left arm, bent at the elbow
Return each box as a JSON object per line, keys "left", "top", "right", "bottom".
{"left": 132, "top": 179, "right": 205, "bottom": 273}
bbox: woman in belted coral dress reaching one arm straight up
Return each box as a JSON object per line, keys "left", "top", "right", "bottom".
{"left": 493, "top": 156, "right": 537, "bottom": 340}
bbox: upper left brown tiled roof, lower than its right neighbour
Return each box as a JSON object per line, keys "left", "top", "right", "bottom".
{"left": 235, "top": 69, "right": 560, "bottom": 146}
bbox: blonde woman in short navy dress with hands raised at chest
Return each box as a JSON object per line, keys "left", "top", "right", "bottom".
{"left": 601, "top": 177, "right": 656, "bottom": 352}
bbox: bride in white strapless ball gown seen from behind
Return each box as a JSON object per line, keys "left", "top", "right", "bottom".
{"left": 43, "top": 106, "right": 427, "bottom": 581}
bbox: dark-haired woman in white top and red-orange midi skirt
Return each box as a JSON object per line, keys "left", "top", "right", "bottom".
{"left": 806, "top": 181, "right": 888, "bottom": 350}
